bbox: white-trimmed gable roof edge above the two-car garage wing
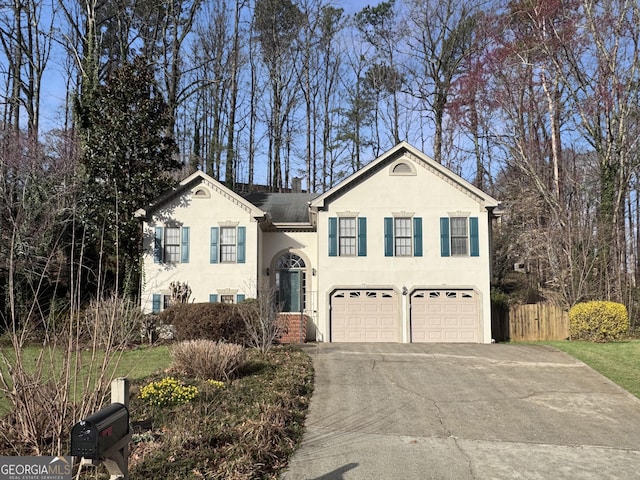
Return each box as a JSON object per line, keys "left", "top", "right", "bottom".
{"left": 310, "top": 142, "right": 500, "bottom": 210}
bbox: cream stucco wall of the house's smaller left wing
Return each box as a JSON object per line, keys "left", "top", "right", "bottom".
{"left": 141, "top": 182, "right": 258, "bottom": 312}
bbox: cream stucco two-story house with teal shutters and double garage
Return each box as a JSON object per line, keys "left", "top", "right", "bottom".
{"left": 138, "top": 142, "right": 498, "bottom": 343}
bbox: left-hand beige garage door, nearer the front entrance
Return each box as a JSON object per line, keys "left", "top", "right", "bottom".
{"left": 331, "top": 289, "right": 401, "bottom": 342}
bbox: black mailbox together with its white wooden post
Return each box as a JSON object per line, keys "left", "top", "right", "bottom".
{"left": 71, "top": 378, "right": 131, "bottom": 480}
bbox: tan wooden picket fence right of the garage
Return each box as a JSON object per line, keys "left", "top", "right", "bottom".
{"left": 491, "top": 303, "right": 569, "bottom": 342}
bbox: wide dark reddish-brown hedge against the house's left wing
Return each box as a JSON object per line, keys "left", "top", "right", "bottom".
{"left": 159, "top": 303, "right": 247, "bottom": 345}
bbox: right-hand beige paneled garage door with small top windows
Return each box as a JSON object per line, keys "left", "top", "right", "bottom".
{"left": 411, "top": 289, "right": 480, "bottom": 343}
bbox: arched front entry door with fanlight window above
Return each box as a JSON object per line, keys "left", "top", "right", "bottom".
{"left": 275, "top": 252, "right": 307, "bottom": 312}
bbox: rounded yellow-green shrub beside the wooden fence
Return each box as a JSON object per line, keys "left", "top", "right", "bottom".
{"left": 569, "top": 301, "right": 629, "bottom": 342}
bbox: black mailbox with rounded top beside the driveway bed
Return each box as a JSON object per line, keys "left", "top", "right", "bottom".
{"left": 71, "top": 403, "right": 129, "bottom": 460}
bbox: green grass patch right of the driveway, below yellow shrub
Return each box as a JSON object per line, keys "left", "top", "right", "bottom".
{"left": 541, "top": 340, "right": 640, "bottom": 397}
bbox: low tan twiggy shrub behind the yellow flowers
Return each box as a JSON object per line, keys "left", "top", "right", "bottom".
{"left": 171, "top": 339, "right": 246, "bottom": 380}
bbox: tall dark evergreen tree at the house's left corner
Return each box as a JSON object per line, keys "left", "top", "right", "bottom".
{"left": 77, "top": 57, "right": 181, "bottom": 292}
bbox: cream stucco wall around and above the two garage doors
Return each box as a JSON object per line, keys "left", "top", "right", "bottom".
{"left": 318, "top": 156, "right": 491, "bottom": 342}
